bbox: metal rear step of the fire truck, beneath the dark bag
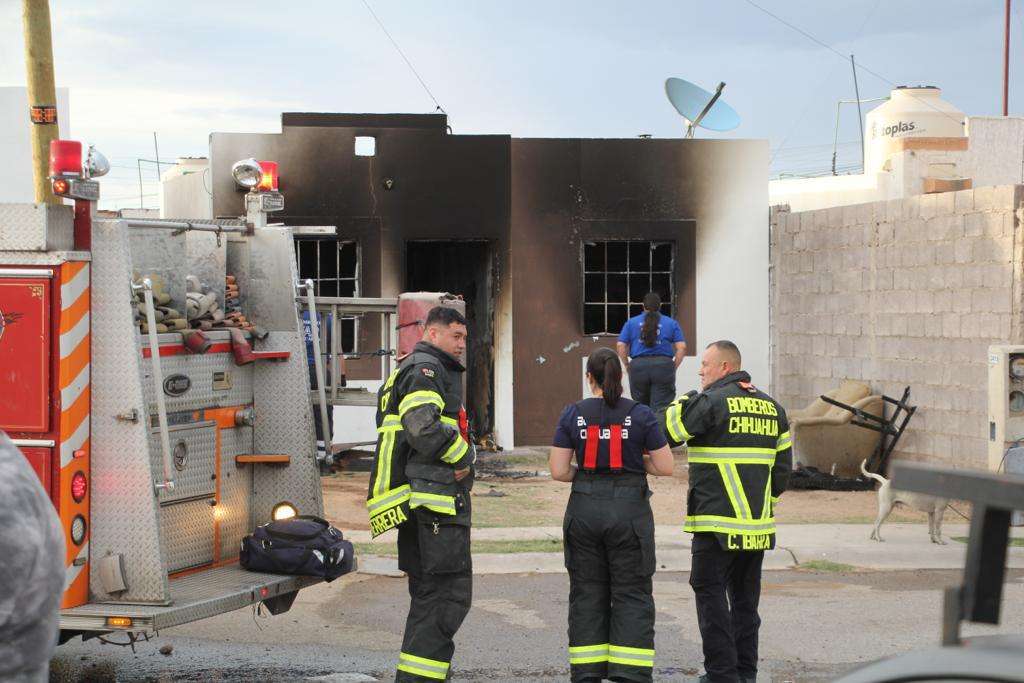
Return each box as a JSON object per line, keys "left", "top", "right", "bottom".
{"left": 60, "top": 564, "right": 322, "bottom": 633}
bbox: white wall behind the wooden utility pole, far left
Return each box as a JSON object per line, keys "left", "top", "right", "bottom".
{"left": 0, "top": 87, "right": 72, "bottom": 203}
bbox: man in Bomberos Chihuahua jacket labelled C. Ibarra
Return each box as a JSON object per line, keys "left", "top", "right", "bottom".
{"left": 666, "top": 341, "right": 793, "bottom": 683}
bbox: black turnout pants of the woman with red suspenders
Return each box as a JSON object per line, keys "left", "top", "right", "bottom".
{"left": 563, "top": 473, "right": 654, "bottom": 681}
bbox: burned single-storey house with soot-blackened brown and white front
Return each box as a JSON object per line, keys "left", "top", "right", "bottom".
{"left": 195, "top": 114, "right": 769, "bottom": 446}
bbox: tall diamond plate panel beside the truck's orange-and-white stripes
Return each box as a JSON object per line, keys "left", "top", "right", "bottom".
{"left": 89, "top": 220, "right": 168, "bottom": 602}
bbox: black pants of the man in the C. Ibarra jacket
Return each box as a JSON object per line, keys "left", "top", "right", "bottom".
{"left": 690, "top": 533, "right": 764, "bottom": 683}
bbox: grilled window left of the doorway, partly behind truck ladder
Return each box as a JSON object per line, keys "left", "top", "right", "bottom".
{"left": 295, "top": 237, "right": 359, "bottom": 353}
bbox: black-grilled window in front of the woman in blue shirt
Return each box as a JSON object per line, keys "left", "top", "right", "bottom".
{"left": 583, "top": 240, "right": 676, "bottom": 335}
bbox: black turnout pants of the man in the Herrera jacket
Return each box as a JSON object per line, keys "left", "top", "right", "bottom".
{"left": 394, "top": 508, "right": 473, "bottom": 681}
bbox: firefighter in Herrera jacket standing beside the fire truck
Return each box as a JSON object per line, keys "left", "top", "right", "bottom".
{"left": 367, "top": 306, "right": 476, "bottom": 681}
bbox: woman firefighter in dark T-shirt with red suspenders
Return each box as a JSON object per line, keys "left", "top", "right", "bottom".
{"left": 549, "top": 348, "right": 673, "bottom": 681}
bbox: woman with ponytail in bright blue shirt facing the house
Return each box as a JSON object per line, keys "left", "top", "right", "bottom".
{"left": 616, "top": 292, "right": 686, "bottom": 414}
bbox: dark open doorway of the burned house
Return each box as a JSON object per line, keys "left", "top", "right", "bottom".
{"left": 406, "top": 241, "right": 495, "bottom": 437}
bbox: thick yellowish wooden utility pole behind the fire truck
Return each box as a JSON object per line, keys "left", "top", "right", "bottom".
{"left": 22, "top": 0, "right": 61, "bottom": 204}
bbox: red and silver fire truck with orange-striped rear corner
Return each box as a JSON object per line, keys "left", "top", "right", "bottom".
{"left": 0, "top": 140, "right": 324, "bottom": 642}
